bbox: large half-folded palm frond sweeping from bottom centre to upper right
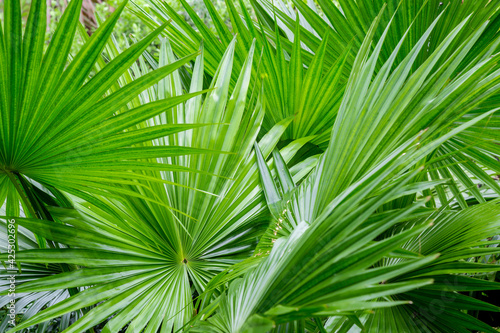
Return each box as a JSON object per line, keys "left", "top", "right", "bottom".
{"left": 185, "top": 7, "right": 498, "bottom": 332}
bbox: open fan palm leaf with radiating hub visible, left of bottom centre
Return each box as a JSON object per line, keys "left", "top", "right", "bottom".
{"left": 0, "top": 33, "right": 318, "bottom": 332}
